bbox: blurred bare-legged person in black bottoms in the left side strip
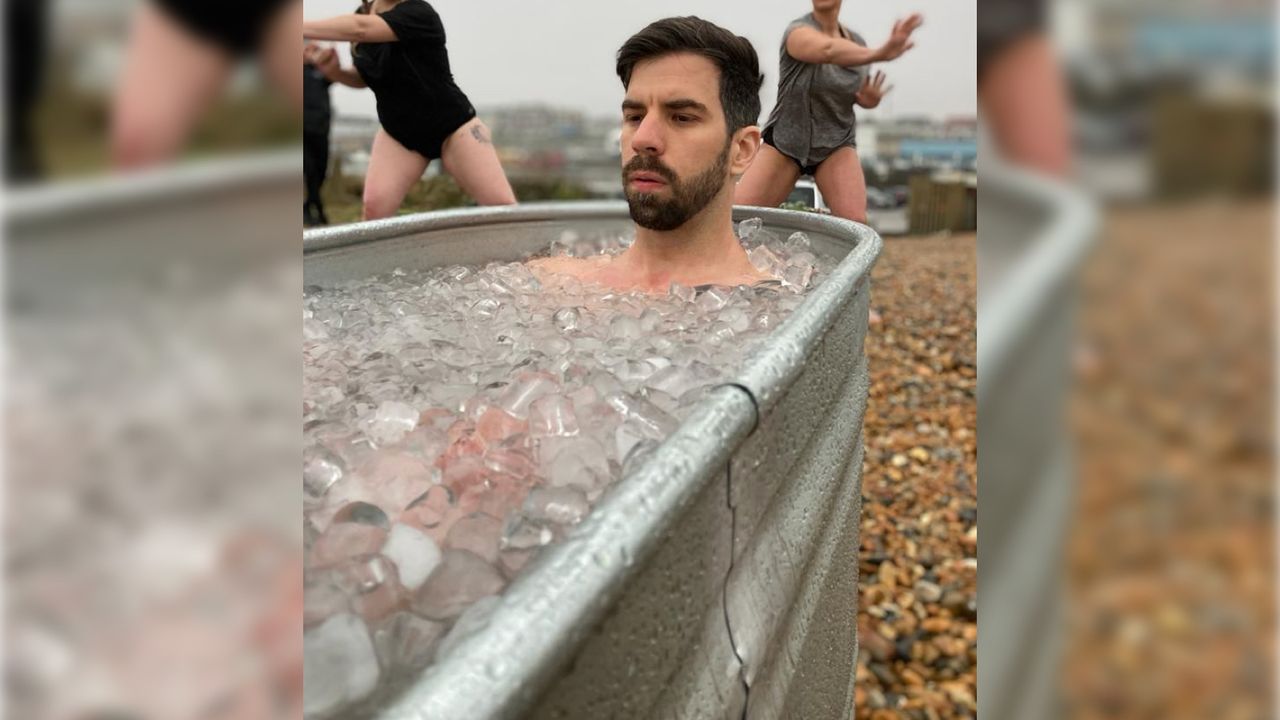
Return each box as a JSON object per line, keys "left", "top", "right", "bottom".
{"left": 110, "top": 0, "right": 302, "bottom": 169}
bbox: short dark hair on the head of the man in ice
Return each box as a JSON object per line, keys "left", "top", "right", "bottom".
{"left": 617, "top": 15, "right": 764, "bottom": 135}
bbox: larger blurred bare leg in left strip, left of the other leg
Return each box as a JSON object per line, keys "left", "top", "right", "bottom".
{"left": 110, "top": 3, "right": 234, "bottom": 169}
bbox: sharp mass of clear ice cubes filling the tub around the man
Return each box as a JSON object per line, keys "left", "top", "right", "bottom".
{"left": 302, "top": 213, "right": 832, "bottom": 717}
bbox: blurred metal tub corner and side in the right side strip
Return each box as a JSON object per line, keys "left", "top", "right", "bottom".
{"left": 978, "top": 167, "right": 1096, "bottom": 720}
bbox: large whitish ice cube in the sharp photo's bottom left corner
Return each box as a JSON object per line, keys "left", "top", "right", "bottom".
{"left": 302, "top": 612, "right": 379, "bottom": 716}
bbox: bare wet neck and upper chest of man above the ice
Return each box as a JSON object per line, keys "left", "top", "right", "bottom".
{"left": 625, "top": 196, "right": 748, "bottom": 288}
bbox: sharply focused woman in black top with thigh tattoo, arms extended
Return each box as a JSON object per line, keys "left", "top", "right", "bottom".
{"left": 302, "top": 0, "right": 516, "bottom": 219}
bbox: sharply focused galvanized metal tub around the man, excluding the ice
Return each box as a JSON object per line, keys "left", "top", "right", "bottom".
{"left": 303, "top": 202, "right": 882, "bottom": 720}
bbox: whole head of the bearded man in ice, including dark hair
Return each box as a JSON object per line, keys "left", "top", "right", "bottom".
{"left": 617, "top": 17, "right": 763, "bottom": 231}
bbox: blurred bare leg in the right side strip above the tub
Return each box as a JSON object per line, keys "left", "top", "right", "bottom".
{"left": 978, "top": 35, "right": 1071, "bottom": 177}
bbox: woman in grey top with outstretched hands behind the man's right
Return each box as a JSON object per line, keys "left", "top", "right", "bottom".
{"left": 733, "top": 0, "right": 924, "bottom": 223}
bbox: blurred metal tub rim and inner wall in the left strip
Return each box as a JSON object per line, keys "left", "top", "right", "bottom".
{"left": 5, "top": 151, "right": 302, "bottom": 302}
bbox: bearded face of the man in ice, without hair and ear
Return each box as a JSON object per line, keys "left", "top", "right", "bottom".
{"left": 622, "top": 53, "right": 730, "bottom": 231}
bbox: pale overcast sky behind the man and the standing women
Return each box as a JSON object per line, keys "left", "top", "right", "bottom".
{"left": 306, "top": 0, "right": 977, "bottom": 122}
